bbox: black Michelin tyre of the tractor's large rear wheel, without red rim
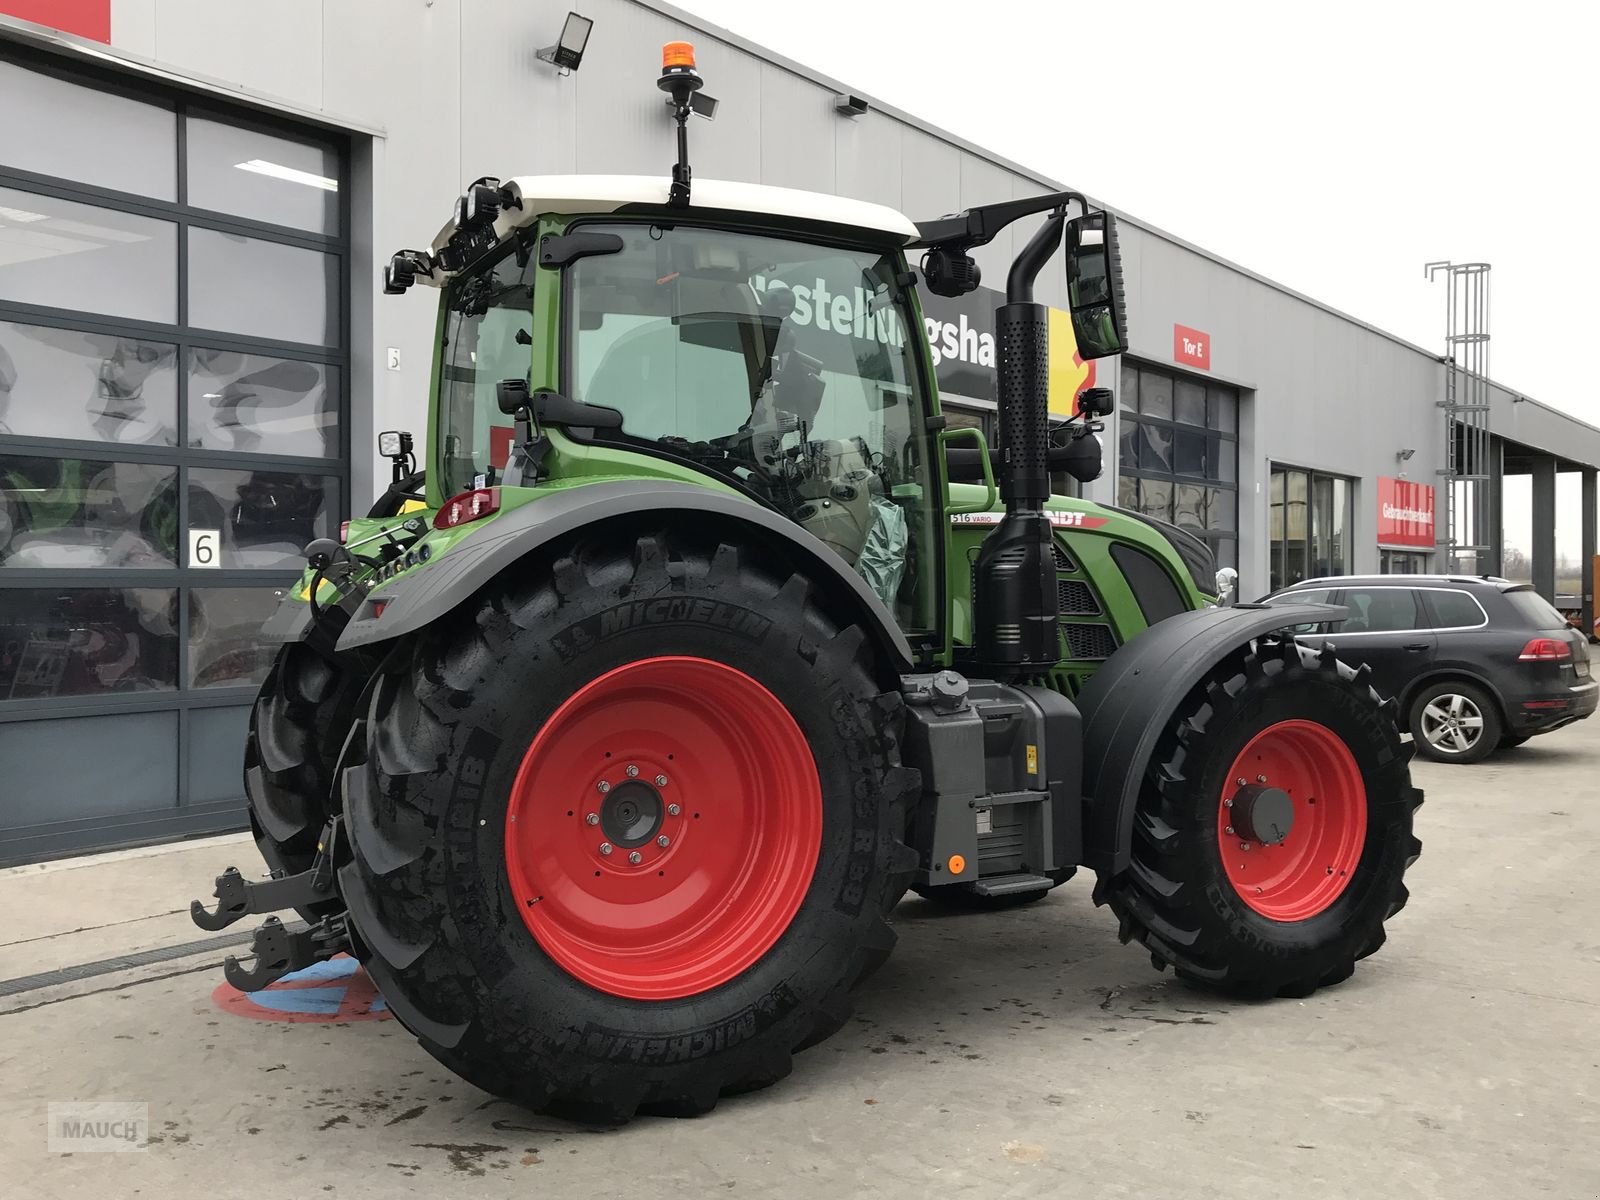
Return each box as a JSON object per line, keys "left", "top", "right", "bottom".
{"left": 339, "top": 533, "right": 920, "bottom": 1125}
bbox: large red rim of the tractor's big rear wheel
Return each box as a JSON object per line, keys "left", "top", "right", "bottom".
{"left": 506, "top": 658, "right": 822, "bottom": 1000}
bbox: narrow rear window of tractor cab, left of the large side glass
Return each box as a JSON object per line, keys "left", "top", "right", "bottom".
{"left": 438, "top": 253, "right": 536, "bottom": 496}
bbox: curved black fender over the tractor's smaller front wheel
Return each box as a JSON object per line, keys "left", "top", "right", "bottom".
{"left": 1077, "top": 605, "right": 1347, "bottom": 877}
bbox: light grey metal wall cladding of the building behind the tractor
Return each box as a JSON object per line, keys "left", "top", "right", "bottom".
{"left": 46, "top": 0, "right": 1600, "bottom": 592}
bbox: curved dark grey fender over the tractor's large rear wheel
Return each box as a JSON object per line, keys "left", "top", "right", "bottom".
{"left": 339, "top": 480, "right": 912, "bottom": 672}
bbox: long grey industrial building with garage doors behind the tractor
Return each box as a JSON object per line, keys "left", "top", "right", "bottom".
{"left": 0, "top": 0, "right": 1600, "bottom": 862}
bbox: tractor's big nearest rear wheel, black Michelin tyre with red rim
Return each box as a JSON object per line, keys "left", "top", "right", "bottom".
{"left": 341, "top": 538, "right": 917, "bottom": 1122}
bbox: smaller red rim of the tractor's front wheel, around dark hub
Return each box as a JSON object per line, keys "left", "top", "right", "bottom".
{"left": 1216, "top": 720, "right": 1366, "bottom": 922}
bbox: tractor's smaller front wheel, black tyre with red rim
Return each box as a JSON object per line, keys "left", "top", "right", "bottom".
{"left": 1096, "top": 642, "right": 1421, "bottom": 997}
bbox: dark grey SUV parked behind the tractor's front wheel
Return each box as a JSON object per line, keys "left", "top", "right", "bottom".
{"left": 1266, "top": 574, "right": 1600, "bottom": 763}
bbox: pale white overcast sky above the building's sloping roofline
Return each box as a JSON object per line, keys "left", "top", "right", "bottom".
{"left": 677, "top": 0, "right": 1600, "bottom": 563}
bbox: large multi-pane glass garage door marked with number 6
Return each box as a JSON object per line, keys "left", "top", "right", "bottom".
{"left": 0, "top": 46, "right": 350, "bottom": 862}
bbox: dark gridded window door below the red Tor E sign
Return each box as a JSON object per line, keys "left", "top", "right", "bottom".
{"left": 1117, "top": 363, "right": 1238, "bottom": 566}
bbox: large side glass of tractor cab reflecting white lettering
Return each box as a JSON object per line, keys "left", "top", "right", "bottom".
{"left": 565, "top": 222, "right": 936, "bottom": 629}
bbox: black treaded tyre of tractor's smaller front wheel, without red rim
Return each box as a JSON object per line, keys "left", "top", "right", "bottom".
{"left": 1094, "top": 642, "right": 1422, "bottom": 997}
